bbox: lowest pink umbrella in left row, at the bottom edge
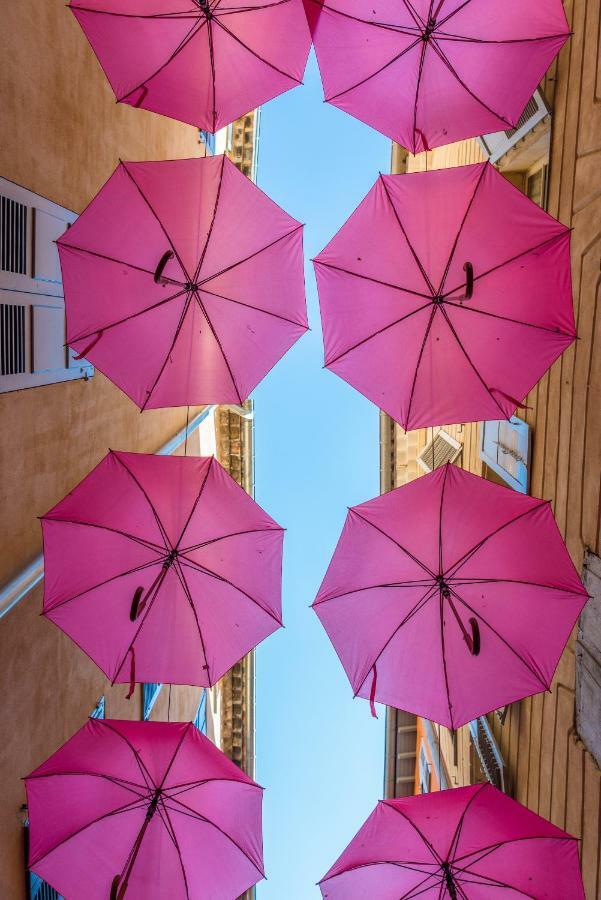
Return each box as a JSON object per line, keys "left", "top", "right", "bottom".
{"left": 25, "top": 719, "right": 264, "bottom": 900}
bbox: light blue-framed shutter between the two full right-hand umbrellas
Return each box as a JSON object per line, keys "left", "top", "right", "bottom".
{"left": 480, "top": 416, "right": 530, "bottom": 494}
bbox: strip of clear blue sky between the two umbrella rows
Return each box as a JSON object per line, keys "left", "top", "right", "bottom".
{"left": 254, "top": 54, "right": 390, "bottom": 900}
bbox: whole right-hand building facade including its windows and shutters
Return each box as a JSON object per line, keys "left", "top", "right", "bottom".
{"left": 381, "top": 0, "right": 601, "bottom": 900}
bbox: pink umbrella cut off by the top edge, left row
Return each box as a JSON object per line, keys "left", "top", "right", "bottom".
{"left": 70, "top": 0, "right": 311, "bottom": 132}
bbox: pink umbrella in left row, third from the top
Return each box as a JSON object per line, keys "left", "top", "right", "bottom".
{"left": 42, "top": 451, "right": 283, "bottom": 686}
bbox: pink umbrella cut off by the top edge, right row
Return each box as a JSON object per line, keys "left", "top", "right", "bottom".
{"left": 304, "top": 0, "right": 569, "bottom": 153}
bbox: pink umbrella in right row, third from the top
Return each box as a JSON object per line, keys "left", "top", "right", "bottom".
{"left": 313, "top": 464, "right": 587, "bottom": 728}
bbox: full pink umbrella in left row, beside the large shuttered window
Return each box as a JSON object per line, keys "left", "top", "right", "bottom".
{"left": 58, "top": 156, "right": 307, "bottom": 409}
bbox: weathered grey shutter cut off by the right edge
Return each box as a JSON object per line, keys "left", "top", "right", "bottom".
{"left": 576, "top": 550, "right": 601, "bottom": 765}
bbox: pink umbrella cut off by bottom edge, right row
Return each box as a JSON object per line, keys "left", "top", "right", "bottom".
{"left": 320, "top": 784, "right": 584, "bottom": 900}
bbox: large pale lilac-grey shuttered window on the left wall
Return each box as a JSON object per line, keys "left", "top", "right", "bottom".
{"left": 0, "top": 178, "right": 94, "bottom": 393}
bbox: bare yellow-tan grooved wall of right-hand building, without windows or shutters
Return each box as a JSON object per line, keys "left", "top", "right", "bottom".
{"left": 381, "top": 0, "right": 601, "bottom": 900}
